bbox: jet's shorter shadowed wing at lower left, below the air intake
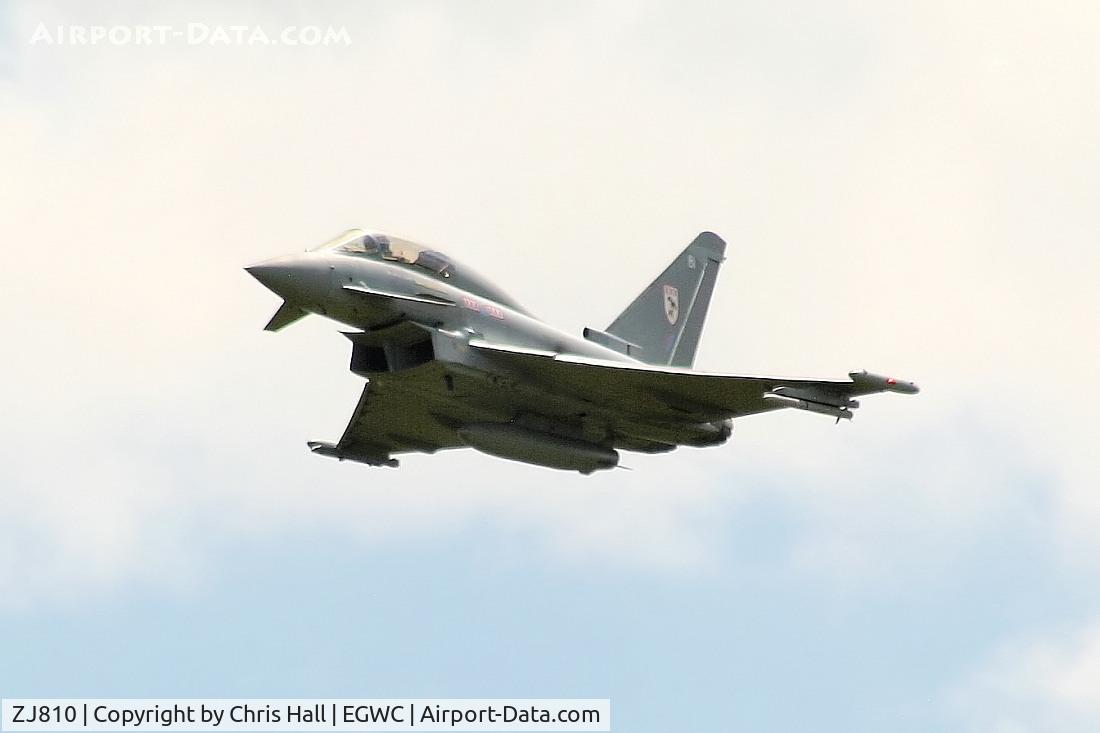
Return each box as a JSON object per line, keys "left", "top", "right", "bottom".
{"left": 308, "top": 362, "right": 464, "bottom": 466}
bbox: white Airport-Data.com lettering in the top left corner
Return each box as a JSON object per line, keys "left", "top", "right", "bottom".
{"left": 29, "top": 23, "right": 351, "bottom": 46}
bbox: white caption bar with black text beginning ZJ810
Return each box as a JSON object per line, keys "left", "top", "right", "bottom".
{"left": 0, "top": 699, "right": 612, "bottom": 732}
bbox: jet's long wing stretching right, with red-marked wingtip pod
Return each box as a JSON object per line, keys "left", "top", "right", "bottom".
{"left": 470, "top": 340, "right": 919, "bottom": 423}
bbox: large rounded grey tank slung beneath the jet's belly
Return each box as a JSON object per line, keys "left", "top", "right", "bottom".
{"left": 459, "top": 423, "right": 619, "bottom": 473}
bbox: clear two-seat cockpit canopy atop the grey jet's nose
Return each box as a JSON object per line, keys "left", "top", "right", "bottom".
{"left": 316, "top": 229, "right": 526, "bottom": 313}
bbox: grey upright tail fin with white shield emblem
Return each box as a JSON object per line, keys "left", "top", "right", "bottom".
{"left": 607, "top": 231, "right": 726, "bottom": 367}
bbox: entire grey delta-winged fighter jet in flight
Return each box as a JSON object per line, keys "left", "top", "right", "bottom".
{"left": 245, "top": 229, "right": 917, "bottom": 474}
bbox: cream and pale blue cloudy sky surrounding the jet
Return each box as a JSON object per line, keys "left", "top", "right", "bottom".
{"left": 0, "top": 2, "right": 1100, "bottom": 732}
